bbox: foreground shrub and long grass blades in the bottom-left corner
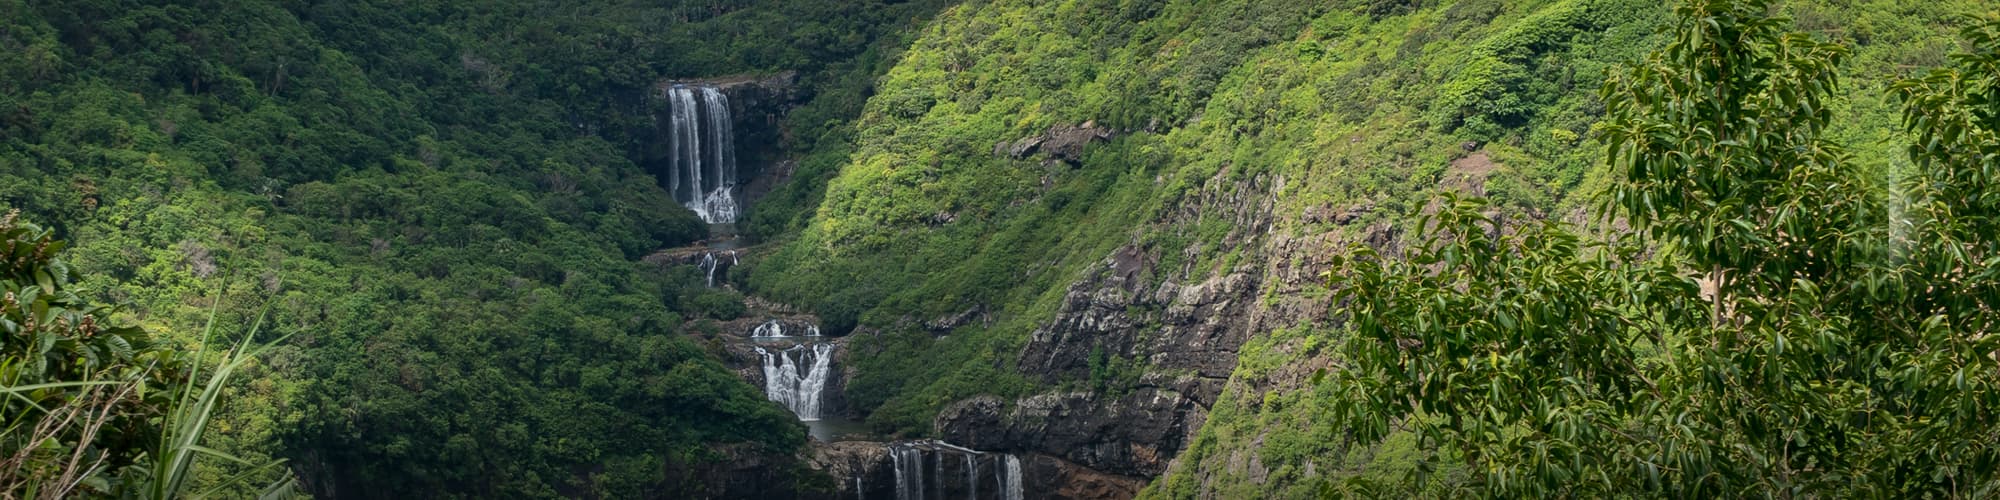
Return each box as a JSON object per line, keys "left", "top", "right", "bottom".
{"left": 0, "top": 212, "right": 290, "bottom": 500}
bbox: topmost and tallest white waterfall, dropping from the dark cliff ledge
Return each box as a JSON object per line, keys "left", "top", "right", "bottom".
{"left": 666, "top": 86, "right": 740, "bottom": 224}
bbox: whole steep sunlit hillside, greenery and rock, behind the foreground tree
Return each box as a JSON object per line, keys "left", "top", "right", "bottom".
{"left": 748, "top": 0, "right": 1982, "bottom": 498}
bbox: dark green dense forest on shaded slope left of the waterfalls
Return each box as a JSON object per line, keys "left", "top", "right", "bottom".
{"left": 0, "top": 0, "right": 936, "bottom": 498}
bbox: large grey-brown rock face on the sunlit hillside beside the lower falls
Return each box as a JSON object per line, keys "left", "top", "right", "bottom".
{"left": 934, "top": 167, "right": 1320, "bottom": 498}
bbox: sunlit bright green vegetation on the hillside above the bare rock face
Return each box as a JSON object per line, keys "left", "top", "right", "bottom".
{"left": 746, "top": 0, "right": 1664, "bottom": 432}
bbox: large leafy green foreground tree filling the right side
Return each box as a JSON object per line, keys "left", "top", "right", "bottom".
{"left": 1336, "top": 0, "right": 2000, "bottom": 496}
